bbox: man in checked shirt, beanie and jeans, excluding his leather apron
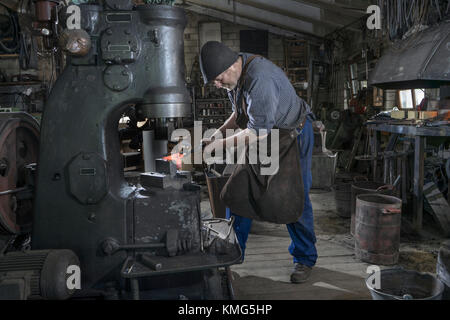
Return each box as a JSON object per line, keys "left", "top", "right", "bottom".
{"left": 200, "top": 41, "right": 317, "bottom": 283}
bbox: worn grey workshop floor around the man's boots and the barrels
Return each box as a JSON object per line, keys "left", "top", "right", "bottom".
{"left": 202, "top": 185, "right": 443, "bottom": 300}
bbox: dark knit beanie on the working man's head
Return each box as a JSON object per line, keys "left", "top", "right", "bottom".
{"left": 200, "top": 41, "right": 239, "bottom": 84}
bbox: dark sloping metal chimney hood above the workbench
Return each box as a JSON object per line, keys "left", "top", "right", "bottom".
{"left": 369, "top": 21, "right": 450, "bottom": 89}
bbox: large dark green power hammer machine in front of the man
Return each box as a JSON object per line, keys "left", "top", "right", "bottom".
{"left": 0, "top": 0, "right": 241, "bottom": 299}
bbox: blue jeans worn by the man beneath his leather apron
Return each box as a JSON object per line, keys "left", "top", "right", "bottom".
{"left": 226, "top": 119, "right": 317, "bottom": 267}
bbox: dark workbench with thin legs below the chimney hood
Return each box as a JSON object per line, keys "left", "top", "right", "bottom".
{"left": 366, "top": 120, "right": 450, "bottom": 232}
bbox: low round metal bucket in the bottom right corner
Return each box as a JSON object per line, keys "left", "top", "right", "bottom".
{"left": 366, "top": 268, "right": 444, "bottom": 300}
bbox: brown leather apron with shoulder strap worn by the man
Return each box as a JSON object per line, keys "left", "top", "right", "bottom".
{"left": 220, "top": 55, "right": 304, "bottom": 224}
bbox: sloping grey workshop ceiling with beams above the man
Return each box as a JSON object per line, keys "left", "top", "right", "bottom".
{"left": 175, "top": 0, "right": 371, "bottom": 37}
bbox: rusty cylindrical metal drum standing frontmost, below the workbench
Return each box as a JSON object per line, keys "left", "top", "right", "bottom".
{"left": 355, "top": 194, "right": 402, "bottom": 265}
